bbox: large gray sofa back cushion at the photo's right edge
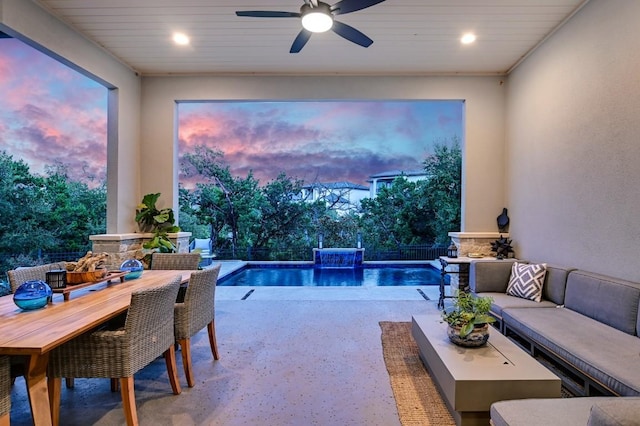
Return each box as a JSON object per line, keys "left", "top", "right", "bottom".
{"left": 564, "top": 270, "right": 640, "bottom": 335}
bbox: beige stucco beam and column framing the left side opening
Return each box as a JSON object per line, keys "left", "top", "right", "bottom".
{"left": 0, "top": 0, "right": 140, "bottom": 233}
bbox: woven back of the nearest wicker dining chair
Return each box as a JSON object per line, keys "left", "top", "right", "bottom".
{"left": 124, "top": 275, "right": 182, "bottom": 371}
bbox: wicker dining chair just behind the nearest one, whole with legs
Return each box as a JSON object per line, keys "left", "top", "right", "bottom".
{"left": 175, "top": 264, "right": 221, "bottom": 387}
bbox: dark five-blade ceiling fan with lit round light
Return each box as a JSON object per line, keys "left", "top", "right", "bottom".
{"left": 236, "top": 0, "right": 385, "bottom": 53}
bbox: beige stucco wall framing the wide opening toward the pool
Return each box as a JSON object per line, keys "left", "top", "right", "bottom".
{"left": 141, "top": 76, "right": 505, "bottom": 231}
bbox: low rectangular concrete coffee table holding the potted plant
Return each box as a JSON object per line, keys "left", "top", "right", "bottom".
{"left": 411, "top": 315, "right": 561, "bottom": 426}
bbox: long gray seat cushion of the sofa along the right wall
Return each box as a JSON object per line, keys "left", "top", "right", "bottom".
{"left": 502, "top": 308, "right": 640, "bottom": 396}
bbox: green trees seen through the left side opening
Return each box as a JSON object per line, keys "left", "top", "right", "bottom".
{"left": 0, "top": 152, "right": 106, "bottom": 270}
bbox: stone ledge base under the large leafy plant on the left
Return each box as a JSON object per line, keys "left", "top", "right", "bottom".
{"left": 89, "top": 232, "right": 191, "bottom": 270}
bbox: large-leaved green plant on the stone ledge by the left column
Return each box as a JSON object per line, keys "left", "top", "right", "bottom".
{"left": 136, "top": 192, "right": 180, "bottom": 253}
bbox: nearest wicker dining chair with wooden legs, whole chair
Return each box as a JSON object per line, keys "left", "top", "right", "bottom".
{"left": 48, "top": 276, "right": 181, "bottom": 425}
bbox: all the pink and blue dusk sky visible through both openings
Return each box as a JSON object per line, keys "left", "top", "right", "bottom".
{"left": 0, "top": 38, "right": 463, "bottom": 190}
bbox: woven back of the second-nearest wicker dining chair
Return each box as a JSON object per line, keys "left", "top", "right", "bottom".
{"left": 175, "top": 264, "right": 221, "bottom": 339}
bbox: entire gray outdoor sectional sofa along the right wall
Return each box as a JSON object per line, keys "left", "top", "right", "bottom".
{"left": 469, "top": 260, "right": 640, "bottom": 425}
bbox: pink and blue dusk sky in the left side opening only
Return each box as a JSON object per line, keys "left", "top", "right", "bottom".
{"left": 0, "top": 38, "right": 107, "bottom": 184}
